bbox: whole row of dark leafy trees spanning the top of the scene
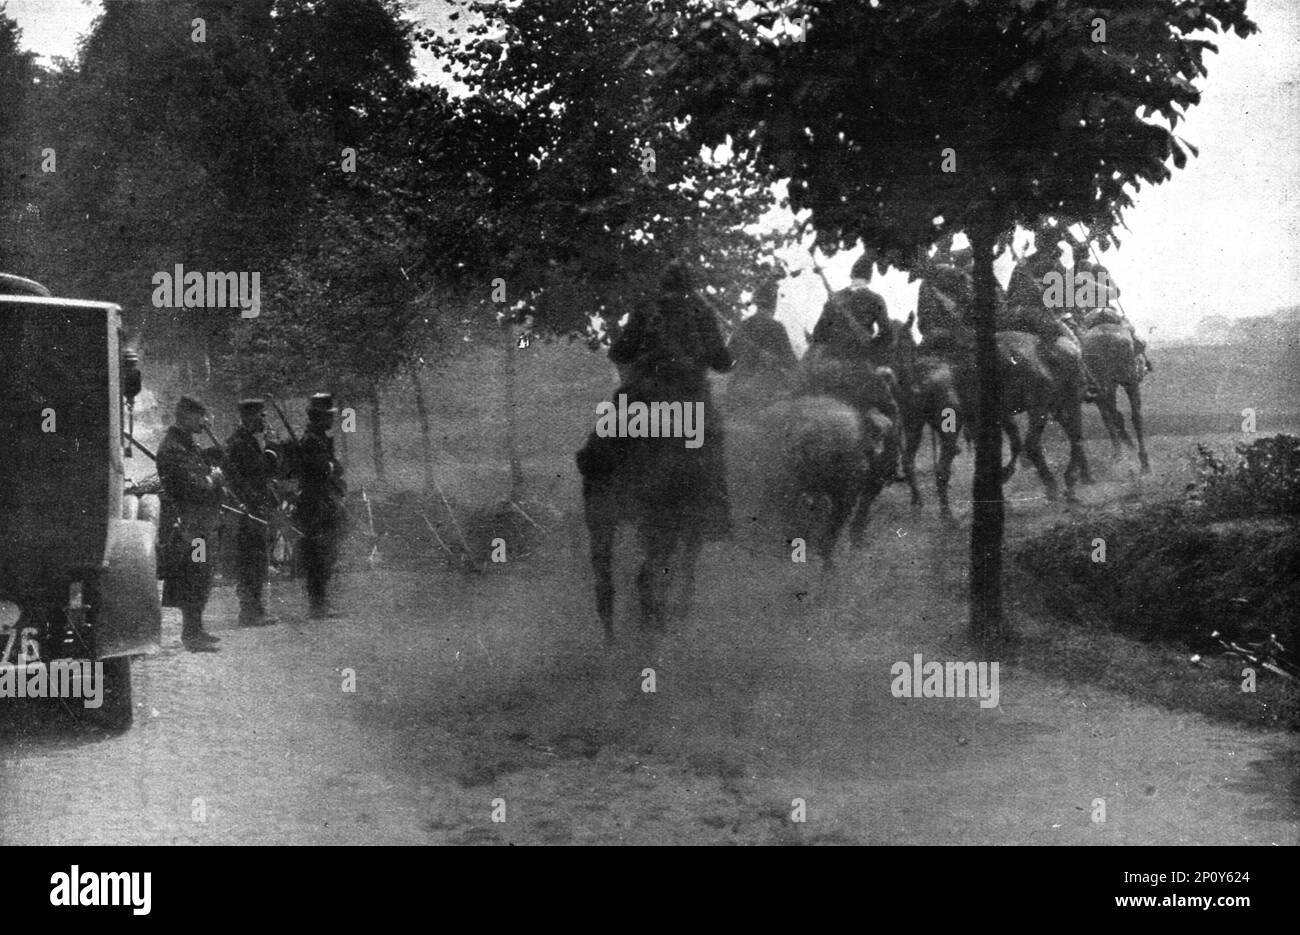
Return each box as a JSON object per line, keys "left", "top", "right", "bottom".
{"left": 0, "top": 0, "right": 1255, "bottom": 636}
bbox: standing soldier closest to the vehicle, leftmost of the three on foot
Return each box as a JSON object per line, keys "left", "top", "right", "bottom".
{"left": 157, "top": 397, "right": 224, "bottom": 653}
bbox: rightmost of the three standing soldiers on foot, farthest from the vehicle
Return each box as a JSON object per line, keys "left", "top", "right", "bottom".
{"left": 293, "top": 393, "right": 347, "bottom": 619}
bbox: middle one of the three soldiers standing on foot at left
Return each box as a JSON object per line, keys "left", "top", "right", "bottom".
{"left": 225, "top": 399, "right": 280, "bottom": 627}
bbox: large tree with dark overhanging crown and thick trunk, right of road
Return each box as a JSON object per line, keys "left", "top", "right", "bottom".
{"left": 632, "top": 0, "right": 1255, "bottom": 637}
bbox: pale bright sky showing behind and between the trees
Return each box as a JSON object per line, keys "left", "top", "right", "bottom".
{"left": 0, "top": 0, "right": 1300, "bottom": 343}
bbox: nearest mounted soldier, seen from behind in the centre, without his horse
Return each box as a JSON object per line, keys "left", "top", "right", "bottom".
{"left": 577, "top": 260, "right": 736, "bottom": 540}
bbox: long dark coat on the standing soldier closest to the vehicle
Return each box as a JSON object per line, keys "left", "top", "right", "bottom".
{"left": 157, "top": 425, "right": 221, "bottom": 607}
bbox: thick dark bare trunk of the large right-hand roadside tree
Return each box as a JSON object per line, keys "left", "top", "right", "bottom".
{"left": 969, "top": 226, "right": 1005, "bottom": 642}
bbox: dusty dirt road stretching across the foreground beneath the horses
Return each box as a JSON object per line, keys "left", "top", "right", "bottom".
{"left": 0, "top": 429, "right": 1300, "bottom": 845}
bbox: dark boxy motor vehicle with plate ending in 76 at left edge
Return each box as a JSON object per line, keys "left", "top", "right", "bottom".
{"left": 0, "top": 273, "right": 161, "bottom": 730}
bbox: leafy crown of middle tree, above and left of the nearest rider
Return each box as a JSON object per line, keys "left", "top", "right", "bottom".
{"left": 426, "top": 0, "right": 781, "bottom": 332}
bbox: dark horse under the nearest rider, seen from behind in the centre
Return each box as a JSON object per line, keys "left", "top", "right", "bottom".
{"left": 579, "top": 369, "right": 720, "bottom": 642}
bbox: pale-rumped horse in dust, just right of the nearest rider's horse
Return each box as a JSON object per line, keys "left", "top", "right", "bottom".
{"left": 770, "top": 321, "right": 910, "bottom": 573}
